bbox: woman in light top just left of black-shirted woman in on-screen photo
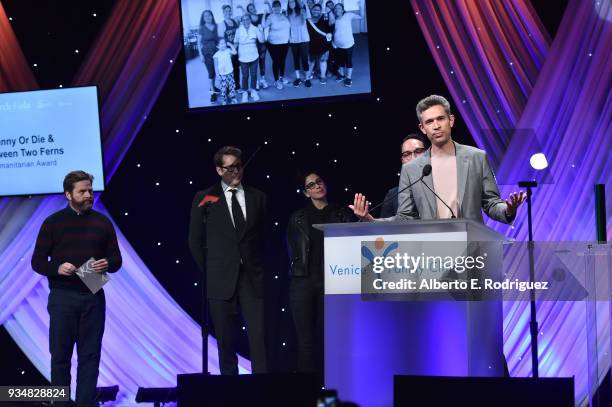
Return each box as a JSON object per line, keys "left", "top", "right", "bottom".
{"left": 287, "top": 0, "right": 312, "bottom": 88}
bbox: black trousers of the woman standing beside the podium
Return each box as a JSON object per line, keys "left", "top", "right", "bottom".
{"left": 289, "top": 276, "right": 323, "bottom": 380}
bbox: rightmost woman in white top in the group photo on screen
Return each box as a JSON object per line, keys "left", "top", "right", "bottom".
{"left": 333, "top": 3, "right": 361, "bottom": 87}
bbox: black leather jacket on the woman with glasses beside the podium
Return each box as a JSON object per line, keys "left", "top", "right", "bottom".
{"left": 287, "top": 204, "right": 354, "bottom": 277}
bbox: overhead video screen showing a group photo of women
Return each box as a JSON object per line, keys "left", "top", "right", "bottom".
{"left": 181, "top": 0, "right": 371, "bottom": 108}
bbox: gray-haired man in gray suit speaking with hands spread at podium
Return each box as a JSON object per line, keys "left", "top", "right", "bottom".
{"left": 349, "top": 95, "right": 526, "bottom": 223}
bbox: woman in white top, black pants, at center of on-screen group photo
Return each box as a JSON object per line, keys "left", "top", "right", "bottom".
{"left": 264, "top": 0, "right": 291, "bottom": 90}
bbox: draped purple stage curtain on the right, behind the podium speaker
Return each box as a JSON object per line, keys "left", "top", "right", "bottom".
{"left": 411, "top": 0, "right": 612, "bottom": 404}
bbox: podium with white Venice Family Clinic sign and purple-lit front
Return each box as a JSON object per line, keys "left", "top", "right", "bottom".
{"left": 315, "top": 219, "right": 506, "bottom": 407}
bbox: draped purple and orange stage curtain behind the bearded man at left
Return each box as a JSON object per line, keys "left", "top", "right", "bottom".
{"left": 0, "top": 0, "right": 250, "bottom": 405}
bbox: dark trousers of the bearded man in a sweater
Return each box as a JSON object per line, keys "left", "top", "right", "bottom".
{"left": 47, "top": 289, "right": 106, "bottom": 407}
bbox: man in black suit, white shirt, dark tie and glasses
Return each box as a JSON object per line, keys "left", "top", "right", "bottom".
{"left": 189, "top": 146, "right": 267, "bottom": 375}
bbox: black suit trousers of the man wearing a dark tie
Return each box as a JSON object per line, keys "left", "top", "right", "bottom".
{"left": 208, "top": 268, "right": 268, "bottom": 375}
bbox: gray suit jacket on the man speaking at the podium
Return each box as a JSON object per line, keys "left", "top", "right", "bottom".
{"left": 389, "top": 143, "right": 514, "bottom": 223}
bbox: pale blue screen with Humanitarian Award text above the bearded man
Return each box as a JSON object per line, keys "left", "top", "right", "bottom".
{"left": 0, "top": 86, "right": 104, "bottom": 196}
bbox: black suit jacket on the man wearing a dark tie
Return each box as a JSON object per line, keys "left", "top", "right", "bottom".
{"left": 189, "top": 183, "right": 267, "bottom": 300}
